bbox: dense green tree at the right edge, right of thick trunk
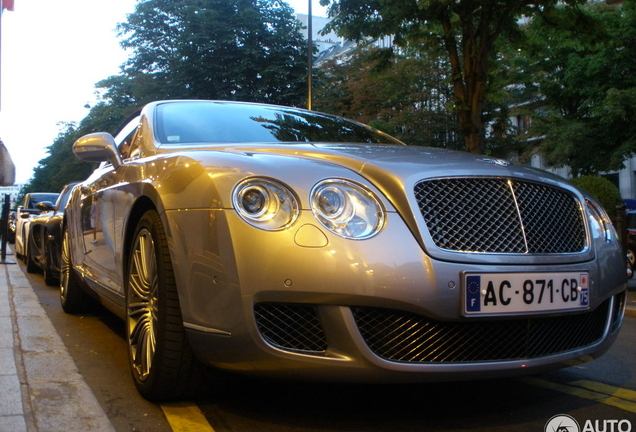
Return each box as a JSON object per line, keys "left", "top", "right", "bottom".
{"left": 517, "top": 0, "right": 636, "bottom": 176}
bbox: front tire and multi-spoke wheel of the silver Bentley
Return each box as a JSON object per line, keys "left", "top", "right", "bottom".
{"left": 125, "top": 210, "right": 203, "bottom": 401}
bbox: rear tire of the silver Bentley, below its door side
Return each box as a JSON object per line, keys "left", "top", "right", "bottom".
{"left": 60, "top": 227, "right": 93, "bottom": 314}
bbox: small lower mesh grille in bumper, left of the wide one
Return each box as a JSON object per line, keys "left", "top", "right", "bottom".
{"left": 254, "top": 303, "right": 327, "bottom": 353}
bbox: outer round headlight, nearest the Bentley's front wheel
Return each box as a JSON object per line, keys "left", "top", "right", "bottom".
{"left": 232, "top": 178, "right": 299, "bottom": 231}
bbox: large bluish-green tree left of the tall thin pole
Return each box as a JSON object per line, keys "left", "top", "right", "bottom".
{"left": 113, "top": 0, "right": 307, "bottom": 105}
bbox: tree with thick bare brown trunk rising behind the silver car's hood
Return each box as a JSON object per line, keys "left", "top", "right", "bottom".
{"left": 321, "top": 0, "right": 584, "bottom": 153}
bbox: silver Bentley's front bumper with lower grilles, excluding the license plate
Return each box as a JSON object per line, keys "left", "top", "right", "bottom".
{"left": 167, "top": 211, "right": 626, "bottom": 382}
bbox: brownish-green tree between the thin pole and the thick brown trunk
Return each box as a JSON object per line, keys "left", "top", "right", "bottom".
{"left": 314, "top": 47, "right": 458, "bottom": 148}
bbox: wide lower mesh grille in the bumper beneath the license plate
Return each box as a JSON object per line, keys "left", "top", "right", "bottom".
{"left": 352, "top": 300, "right": 610, "bottom": 363}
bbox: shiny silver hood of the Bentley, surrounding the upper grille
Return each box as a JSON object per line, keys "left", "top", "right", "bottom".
{"left": 157, "top": 143, "right": 593, "bottom": 263}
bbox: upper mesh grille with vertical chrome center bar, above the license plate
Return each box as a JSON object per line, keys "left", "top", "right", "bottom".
{"left": 414, "top": 177, "right": 586, "bottom": 254}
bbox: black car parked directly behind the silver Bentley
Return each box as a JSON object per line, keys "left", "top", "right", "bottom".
{"left": 26, "top": 183, "right": 77, "bottom": 285}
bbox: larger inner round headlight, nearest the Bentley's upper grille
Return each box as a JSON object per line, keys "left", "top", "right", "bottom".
{"left": 310, "top": 179, "right": 384, "bottom": 240}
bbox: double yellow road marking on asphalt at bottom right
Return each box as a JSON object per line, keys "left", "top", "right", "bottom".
{"left": 521, "top": 377, "right": 636, "bottom": 413}
